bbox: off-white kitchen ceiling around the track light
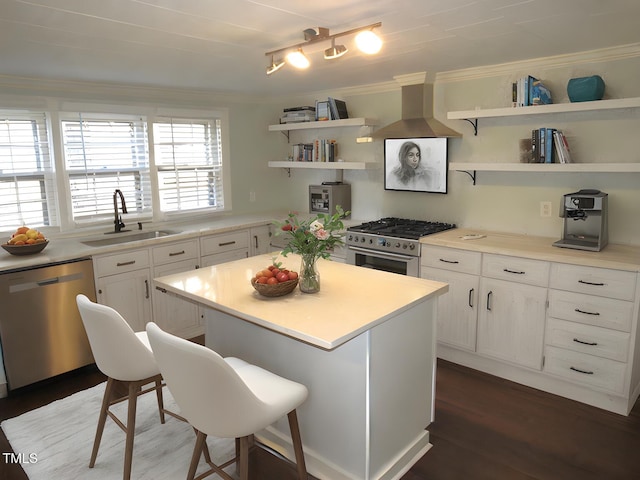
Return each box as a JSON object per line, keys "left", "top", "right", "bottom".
{"left": 0, "top": 0, "right": 640, "bottom": 95}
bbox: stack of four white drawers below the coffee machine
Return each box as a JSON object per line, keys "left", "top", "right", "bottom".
{"left": 544, "top": 264, "right": 637, "bottom": 394}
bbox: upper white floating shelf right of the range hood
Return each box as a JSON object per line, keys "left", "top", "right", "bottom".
{"left": 447, "top": 97, "right": 640, "bottom": 120}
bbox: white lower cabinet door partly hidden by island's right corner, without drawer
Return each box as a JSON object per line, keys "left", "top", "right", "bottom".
{"left": 420, "top": 267, "right": 480, "bottom": 352}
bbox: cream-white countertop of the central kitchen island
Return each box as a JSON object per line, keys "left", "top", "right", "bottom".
{"left": 154, "top": 254, "right": 449, "bottom": 350}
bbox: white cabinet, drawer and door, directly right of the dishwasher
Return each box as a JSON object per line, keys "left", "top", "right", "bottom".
{"left": 93, "top": 248, "right": 152, "bottom": 331}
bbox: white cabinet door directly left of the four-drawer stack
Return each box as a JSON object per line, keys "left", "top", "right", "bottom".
{"left": 477, "top": 278, "right": 547, "bottom": 370}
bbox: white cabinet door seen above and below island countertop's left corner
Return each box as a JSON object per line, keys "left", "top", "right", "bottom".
{"left": 152, "top": 259, "right": 204, "bottom": 338}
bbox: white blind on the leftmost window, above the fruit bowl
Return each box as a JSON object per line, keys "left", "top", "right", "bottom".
{"left": 0, "top": 111, "right": 58, "bottom": 229}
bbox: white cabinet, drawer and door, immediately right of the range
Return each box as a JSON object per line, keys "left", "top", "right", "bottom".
{"left": 420, "top": 246, "right": 481, "bottom": 352}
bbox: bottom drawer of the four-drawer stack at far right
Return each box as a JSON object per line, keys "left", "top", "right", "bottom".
{"left": 544, "top": 346, "right": 627, "bottom": 393}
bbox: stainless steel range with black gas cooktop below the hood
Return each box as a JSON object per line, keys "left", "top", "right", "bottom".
{"left": 345, "top": 217, "right": 455, "bottom": 277}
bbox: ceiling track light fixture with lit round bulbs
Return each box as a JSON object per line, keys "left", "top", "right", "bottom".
{"left": 265, "top": 22, "right": 382, "bottom": 75}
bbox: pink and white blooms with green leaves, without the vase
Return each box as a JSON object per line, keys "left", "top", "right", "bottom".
{"left": 275, "top": 205, "right": 349, "bottom": 259}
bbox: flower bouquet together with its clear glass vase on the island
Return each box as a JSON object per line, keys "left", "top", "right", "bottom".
{"left": 275, "top": 205, "right": 349, "bottom": 293}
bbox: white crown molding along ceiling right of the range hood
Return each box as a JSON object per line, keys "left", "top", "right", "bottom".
{"left": 436, "top": 43, "right": 640, "bottom": 82}
